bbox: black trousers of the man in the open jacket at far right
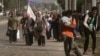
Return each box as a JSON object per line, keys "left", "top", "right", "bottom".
{"left": 84, "top": 29, "right": 96, "bottom": 52}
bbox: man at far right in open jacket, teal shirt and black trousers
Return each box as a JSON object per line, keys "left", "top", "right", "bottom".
{"left": 83, "top": 7, "right": 98, "bottom": 54}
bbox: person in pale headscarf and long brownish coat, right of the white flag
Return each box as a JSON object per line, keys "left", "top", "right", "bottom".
{"left": 36, "top": 11, "right": 46, "bottom": 46}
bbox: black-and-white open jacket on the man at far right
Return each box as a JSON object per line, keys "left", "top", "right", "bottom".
{"left": 83, "top": 13, "right": 98, "bottom": 30}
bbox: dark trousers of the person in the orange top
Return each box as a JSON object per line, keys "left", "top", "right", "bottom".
{"left": 63, "top": 36, "right": 72, "bottom": 56}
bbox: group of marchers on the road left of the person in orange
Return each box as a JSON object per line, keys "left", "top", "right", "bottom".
{"left": 7, "top": 10, "right": 61, "bottom": 46}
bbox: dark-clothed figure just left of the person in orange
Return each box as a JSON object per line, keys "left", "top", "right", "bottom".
{"left": 52, "top": 12, "right": 60, "bottom": 41}
